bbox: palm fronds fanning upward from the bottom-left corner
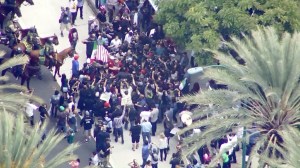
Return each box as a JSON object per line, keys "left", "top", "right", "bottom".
{"left": 0, "top": 110, "right": 79, "bottom": 168}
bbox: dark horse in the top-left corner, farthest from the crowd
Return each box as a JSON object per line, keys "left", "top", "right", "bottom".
{"left": 0, "top": 0, "right": 34, "bottom": 27}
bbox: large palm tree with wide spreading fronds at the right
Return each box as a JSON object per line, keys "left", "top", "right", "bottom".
{"left": 182, "top": 28, "right": 300, "bottom": 165}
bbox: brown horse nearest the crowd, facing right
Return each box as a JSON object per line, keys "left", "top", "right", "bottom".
{"left": 53, "top": 47, "right": 75, "bottom": 81}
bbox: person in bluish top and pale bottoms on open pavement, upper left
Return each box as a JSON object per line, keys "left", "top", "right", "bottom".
{"left": 59, "top": 7, "right": 72, "bottom": 37}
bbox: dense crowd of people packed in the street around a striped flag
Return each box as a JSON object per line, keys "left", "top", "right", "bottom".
{"left": 19, "top": 0, "right": 241, "bottom": 168}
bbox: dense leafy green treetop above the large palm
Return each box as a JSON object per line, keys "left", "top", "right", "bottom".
{"left": 155, "top": 0, "right": 300, "bottom": 63}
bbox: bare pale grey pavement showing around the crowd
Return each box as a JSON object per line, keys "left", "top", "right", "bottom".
{"left": 0, "top": 0, "right": 247, "bottom": 168}
